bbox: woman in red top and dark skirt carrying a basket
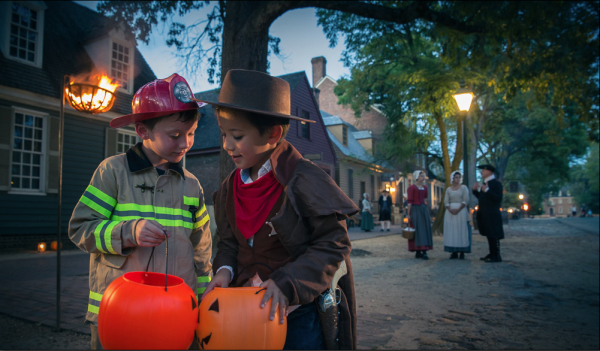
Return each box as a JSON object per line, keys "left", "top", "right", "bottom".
{"left": 407, "top": 171, "right": 433, "bottom": 260}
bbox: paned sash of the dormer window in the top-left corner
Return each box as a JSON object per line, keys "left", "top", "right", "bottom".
{"left": 8, "top": 2, "right": 43, "bottom": 65}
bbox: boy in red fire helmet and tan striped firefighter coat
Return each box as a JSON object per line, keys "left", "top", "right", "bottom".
{"left": 69, "top": 74, "right": 212, "bottom": 349}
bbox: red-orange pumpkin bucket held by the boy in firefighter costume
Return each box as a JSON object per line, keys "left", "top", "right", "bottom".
{"left": 98, "top": 272, "right": 198, "bottom": 350}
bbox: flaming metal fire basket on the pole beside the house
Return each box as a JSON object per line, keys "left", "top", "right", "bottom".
{"left": 65, "top": 74, "right": 120, "bottom": 114}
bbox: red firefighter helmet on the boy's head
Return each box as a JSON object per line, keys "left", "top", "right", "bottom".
{"left": 110, "top": 73, "right": 206, "bottom": 128}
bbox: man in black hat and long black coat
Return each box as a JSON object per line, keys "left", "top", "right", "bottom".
{"left": 473, "top": 165, "right": 504, "bottom": 263}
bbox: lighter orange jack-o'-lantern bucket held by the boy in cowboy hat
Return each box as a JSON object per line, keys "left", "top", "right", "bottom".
{"left": 196, "top": 287, "right": 287, "bottom": 350}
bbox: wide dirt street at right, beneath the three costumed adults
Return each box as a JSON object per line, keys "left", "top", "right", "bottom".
{"left": 352, "top": 220, "right": 599, "bottom": 349}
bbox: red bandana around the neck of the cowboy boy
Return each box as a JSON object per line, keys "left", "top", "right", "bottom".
{"left": 233, "top": 169, "right": 283, "bottom": 239}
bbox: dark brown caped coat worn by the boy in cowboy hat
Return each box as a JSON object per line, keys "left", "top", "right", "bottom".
{"left": 213, "top": 140, "right": 359, "bottom": 349}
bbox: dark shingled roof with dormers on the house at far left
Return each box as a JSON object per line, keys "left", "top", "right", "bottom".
{"left": 0, "top": 1, "right": 156, "bottom": 114}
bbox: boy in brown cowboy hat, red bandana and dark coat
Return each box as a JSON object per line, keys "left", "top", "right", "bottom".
{"left": 205, "top": 70, "right": 359, "bottom": 349}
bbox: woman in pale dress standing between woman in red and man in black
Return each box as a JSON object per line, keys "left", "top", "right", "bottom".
{"left": 444, "top": 171, "right": 471, "bottom": 260}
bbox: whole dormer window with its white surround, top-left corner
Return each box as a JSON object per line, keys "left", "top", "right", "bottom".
{"left": 0, "top": 2, "right": 44, "bottom": 67}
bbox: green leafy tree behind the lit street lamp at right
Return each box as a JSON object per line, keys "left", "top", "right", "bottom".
{"left": 318, "top": 1, "right": 598, "bottom": 229}
